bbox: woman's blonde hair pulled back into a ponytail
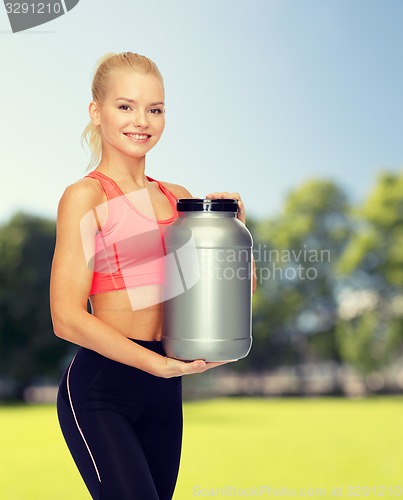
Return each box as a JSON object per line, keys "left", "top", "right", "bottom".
{"left": 81, "top": 52, "right": 164, "bottom": 170}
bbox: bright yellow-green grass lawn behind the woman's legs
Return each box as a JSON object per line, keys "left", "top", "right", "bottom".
{"left": 0, "top": 397, "right": 403, "bottom": 500}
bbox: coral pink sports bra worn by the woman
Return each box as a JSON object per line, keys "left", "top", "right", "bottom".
{"left": 86, "top": 171, "right": 178, "bottom": 295}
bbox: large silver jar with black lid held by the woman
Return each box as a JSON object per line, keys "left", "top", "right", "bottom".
{"left": 162, "top": 199, "right": 253, "bottom": 361}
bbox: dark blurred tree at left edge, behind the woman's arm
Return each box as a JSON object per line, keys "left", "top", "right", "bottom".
{"left": 0, "top": 209, "right": 67, "bottom": 387}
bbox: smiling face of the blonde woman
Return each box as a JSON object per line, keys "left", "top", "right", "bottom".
{"left": 90, "top": 71, "right": 165, "bottom": 158}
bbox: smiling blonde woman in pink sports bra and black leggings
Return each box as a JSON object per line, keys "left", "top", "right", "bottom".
{"left": 50, "top": 52, "right": 251, "bottom": 500}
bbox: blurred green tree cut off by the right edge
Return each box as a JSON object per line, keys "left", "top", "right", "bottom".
{"left": 337, "top": 173, "right": 403, "bottom": 374}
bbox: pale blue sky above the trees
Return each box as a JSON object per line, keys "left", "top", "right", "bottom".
{"left": 0, "top": 0, "right": 403, "bottom": 220}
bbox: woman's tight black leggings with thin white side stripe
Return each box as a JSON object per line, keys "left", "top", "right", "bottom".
{"left": 57, "top": 340, "right": 182, "bottom": 500}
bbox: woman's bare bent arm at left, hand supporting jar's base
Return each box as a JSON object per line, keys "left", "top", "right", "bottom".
{"left": 50, "top": 179, "right": 226, "bottom": 378}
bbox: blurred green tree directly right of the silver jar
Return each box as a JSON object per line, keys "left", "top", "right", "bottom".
{"left": 245, "top": 180, "right": 350, "bottom": 376}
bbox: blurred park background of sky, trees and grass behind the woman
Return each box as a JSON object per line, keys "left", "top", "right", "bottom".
{"left": 0, "top": 0, "right": 403, "bottom": 500}
